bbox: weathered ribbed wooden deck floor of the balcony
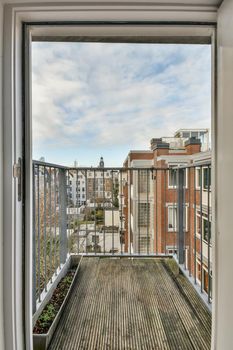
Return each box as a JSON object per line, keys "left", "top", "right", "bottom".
{"left": 49, "top": 258, "right": 211, "bottom": 350}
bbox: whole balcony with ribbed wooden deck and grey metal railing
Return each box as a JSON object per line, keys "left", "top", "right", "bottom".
{"left": 33, "top": 161, "right": 212, "bottom": 349}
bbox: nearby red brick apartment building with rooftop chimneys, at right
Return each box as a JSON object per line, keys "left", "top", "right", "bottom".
{"left": 121, "top": 129, "right": 212, "bottom": 300}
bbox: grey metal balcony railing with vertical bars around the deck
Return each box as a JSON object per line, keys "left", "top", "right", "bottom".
{"left": 33, "top": 161, "right": 212, "bottom": 312}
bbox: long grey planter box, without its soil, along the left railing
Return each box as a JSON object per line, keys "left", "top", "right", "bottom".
{"left": 33, "top": 255, "right": 82, "bottom": 350}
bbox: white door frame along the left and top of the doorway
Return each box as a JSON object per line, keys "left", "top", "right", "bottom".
{"left": 3, "top": 2, "right": 216, "bottom": 350}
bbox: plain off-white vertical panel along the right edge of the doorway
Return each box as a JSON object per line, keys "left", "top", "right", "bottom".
{"left": 213, "top": 0, "right": 233, "bottom": 350}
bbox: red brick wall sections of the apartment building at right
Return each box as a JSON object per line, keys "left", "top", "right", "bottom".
{"left": 124, "top": 139, "right": 211, "bottom": 296}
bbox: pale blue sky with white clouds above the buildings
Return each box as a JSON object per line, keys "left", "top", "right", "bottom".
{"left": 32, "top": 42, "right": 211, "bottom": 166}
